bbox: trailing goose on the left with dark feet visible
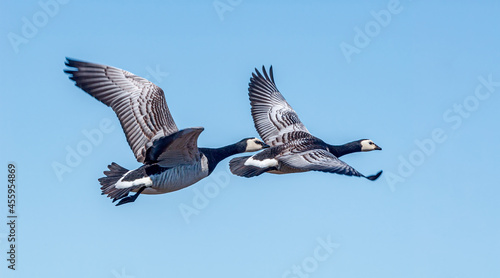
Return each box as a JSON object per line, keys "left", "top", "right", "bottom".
{"left": 64, "top": 58, "right": 269, "bottom": 206}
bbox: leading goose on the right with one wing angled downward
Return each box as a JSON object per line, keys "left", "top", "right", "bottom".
{"left": 229, "top": 66, "right": 382, "bottom": 180}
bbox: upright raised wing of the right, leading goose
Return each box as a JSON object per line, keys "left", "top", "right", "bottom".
{"left": 248, "top": 66, "right": 309, "bottom": 146}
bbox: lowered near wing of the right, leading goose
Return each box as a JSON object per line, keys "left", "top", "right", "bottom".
{"left": 279, "top": 149, "right": 364, "bottom": 177}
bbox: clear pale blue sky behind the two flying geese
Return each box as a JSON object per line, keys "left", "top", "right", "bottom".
{"left": 0, "top": 0, "right": 500, "bottom": 278}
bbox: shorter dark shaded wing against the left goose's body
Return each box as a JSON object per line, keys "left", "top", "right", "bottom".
{"left": 145, "top": 127, "right": 204, "bottom": 167}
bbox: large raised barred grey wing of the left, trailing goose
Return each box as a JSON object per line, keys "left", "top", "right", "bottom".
{"left": 64, "top": 58, "right": 178, "bottom": 162}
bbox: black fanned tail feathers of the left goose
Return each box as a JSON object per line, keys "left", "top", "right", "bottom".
{"left": 99, "top": 162, "right": 140, "bottom": 202}
